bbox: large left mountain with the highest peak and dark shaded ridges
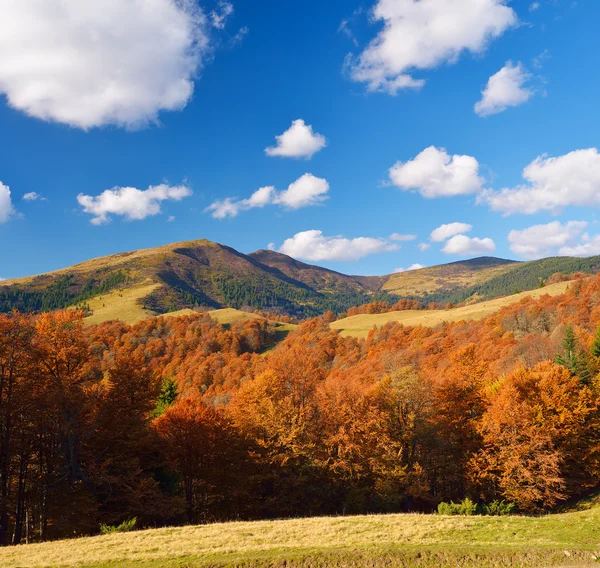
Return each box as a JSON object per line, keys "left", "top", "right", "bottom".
{"left": 0, "top": 240, "right": 390, "bottom": 317}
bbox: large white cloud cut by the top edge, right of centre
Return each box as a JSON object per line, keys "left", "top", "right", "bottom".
{"left": 349, "top": 0, "right": 517, "bottom": 94}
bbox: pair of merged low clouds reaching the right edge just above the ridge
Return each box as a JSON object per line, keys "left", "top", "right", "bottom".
{"left": 508, "top": 221, "right": 600, "bottom": 259}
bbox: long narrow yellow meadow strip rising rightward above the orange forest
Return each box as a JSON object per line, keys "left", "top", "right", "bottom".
{"left": 331, "top": 282, "right": 569, "bottom": 337}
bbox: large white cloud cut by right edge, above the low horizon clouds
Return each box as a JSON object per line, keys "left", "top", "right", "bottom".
{"left": 478, "top": 148, "right": 600, "bottom": 215}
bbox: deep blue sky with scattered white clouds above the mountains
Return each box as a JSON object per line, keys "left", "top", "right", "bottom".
{"left": 0, "top": 0, "right": 600, "bottom": 279}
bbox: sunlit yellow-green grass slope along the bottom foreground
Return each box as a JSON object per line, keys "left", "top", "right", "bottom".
{"left": 0, "top": 507, "right": 600, "bottom": 568}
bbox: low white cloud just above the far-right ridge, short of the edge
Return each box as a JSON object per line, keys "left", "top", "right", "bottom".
{"left": 508, "top": 221, "right": 587, "bottom": 259}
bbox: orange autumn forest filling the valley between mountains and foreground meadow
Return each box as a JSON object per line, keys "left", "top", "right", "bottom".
{"left": 0, "top": 277, "right": 600, "bottom": 545}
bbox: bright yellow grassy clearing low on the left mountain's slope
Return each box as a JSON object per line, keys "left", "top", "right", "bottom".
{"left": 85, "top": 284, "right": 160, "bottom": 325}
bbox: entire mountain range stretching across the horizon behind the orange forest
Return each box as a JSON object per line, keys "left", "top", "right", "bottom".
{"left": 0, "top": 240, "right": 600, "bottom": 320}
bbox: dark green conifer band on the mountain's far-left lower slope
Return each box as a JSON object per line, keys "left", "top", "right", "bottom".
{"left": 0, "top": 270, "right": 129, "bottom": 313}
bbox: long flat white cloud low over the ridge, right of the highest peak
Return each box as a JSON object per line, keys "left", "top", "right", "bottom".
{"left": 279, "top": 230, "right": 398, "bottom": 262}
